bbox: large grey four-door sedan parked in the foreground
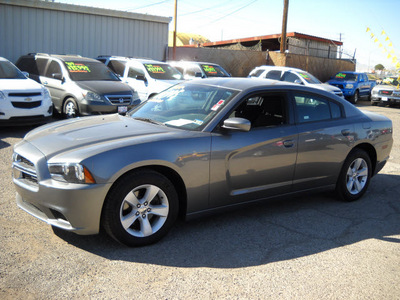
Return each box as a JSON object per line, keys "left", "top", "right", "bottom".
{"left": 12, "top": 78, "right": 393, "bottom": 246}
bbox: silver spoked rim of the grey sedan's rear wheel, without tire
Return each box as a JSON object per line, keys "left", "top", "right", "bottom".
{"left": 346, "top": 158, "right": 368, "bottom": 195}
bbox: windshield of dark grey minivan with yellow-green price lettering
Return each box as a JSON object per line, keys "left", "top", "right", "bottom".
{"left": 64, "top": 61, "right": 120, "bottom": 81}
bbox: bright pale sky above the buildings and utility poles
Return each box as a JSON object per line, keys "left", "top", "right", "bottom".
{"left": 55, "top": 0, "right": 400, "bottom": 71}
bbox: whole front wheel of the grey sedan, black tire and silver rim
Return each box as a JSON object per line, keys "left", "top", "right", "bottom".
{"left": 101, "top": 170, "right": 179, "bottom": 246}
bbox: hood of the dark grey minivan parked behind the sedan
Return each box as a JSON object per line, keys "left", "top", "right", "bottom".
{"left": 75, "top": 80, "right": 132, "bottom": 95}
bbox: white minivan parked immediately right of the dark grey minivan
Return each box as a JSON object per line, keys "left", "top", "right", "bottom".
{"left": 97, "top": 55, "right": 183, "bottom": 101}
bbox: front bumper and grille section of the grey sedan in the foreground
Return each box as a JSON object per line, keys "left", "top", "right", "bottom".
{"left": 12, "top": 143, "right": 111, "bottom": 234}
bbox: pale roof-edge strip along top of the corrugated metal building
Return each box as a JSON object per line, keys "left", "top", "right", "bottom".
{"left": 0, "top": 0, "right": 172, "bottom": 24}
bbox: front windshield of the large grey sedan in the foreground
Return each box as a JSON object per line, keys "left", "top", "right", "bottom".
{"left": 128, "top": 82, "right": 238, "bottom": 130}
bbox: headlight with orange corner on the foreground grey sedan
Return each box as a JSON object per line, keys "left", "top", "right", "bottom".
{"left": 49, "top": 163, "right": 96, "bottom": 183}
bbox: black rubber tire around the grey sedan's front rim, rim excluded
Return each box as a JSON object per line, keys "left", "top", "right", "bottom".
{"left": 102, "top": 170, "right": 179, "bottom": 246}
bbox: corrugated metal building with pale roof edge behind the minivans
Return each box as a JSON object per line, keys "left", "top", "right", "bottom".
{"left": 0, "top": 0, "right": 170, "bottom": 62}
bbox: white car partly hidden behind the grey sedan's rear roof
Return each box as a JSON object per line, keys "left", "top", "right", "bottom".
{"left": 249, "top": 66, "right": 343, "bottom": 97}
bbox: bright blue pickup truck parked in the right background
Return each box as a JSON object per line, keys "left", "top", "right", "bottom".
{"left": 328, "top": 71, "right": 376, "bottom": 104}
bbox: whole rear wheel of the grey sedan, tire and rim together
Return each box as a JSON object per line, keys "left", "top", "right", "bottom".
{"left": 336, "top": 149, "right": 372, "bottom": 202}
